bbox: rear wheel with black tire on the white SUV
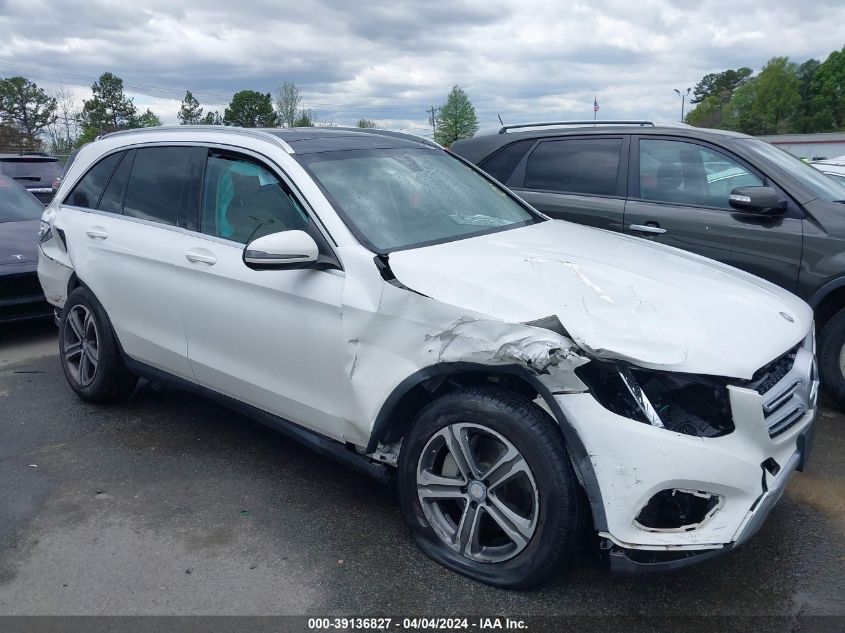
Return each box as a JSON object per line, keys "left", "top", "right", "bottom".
{"left": 59, "top": 287, "right": 138, "bottom": 403}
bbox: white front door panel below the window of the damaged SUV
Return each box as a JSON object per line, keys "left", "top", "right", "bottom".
{"left": 180, "top": 235, "right": 346, "bottom": 439}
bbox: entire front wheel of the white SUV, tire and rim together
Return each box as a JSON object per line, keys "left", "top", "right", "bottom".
{"left": 399, "top": 388, "right": 581, "bottom": 589}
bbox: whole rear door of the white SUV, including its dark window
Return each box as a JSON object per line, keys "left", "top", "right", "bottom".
{"left": 56, "top": 147, "right": 195, "bottom": 380}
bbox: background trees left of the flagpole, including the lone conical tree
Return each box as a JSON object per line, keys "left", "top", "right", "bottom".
{"left": 0, "top": 67, "right": 478, "bottom": 155}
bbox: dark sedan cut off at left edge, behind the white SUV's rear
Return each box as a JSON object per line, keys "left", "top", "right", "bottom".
{"left": 0, "top": 176, "right": 53, "bottom": 323}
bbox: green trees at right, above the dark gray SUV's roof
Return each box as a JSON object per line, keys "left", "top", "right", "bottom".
{"left": 685, "top": 47, "right": 845, "bottom": 134}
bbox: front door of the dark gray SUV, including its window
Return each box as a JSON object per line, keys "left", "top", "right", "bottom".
{"left": 625, "top": 137, "right": 803, "bottom": 290}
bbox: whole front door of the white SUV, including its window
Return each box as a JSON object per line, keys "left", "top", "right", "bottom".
{"left": 179, "top": 150, "right": 347, "bottom": 439}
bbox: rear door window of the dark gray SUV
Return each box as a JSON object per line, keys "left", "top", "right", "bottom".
{"left": 525, "top": 138, "right": 622, "bottom": 196}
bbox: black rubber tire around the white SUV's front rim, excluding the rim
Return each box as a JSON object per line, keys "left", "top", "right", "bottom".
{"left": 399, "top": 387, "right": 584, "bottom": 589}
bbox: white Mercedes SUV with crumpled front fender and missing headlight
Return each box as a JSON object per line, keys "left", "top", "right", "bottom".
{"left": 38, "top": 126, "right": 818, "bottom": 587}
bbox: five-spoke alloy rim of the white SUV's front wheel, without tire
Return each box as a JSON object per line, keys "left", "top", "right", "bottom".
{"left": 417, "top": 423, "right": 540, "bottom": 563}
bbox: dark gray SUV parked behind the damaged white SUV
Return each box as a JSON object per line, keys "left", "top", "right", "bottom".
{"left": 451, "top": 121, "right": 845, "bottom": 407}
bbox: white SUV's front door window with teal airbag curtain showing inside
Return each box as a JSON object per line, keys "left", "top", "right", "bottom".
{"left": 200, "top": 154, "right": 308, "bottom": 244}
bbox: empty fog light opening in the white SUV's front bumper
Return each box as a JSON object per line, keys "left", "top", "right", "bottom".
{"left": 634, "top": 488, "right": 722, "bottom": 532}
